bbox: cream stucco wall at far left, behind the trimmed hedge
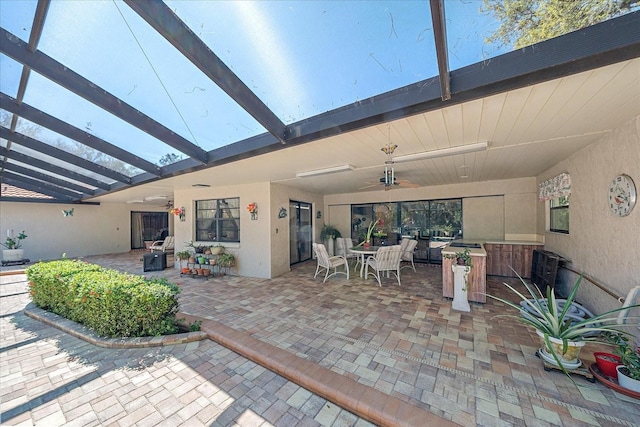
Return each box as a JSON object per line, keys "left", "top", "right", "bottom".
{"left": 0, "top": 202, "right": 165, "bottom": 261}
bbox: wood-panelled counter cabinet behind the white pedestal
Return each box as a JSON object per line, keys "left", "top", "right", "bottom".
{"left": 442, "top": 240, "right": 487, "bottom": 303}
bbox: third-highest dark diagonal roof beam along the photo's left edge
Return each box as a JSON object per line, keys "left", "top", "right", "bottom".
{"left": 0, "top": 126, "right": 131, "bottom": 184}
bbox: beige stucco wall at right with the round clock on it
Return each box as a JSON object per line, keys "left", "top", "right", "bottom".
{"left": 538, "top": 116, "right": 640, "bottom": 320}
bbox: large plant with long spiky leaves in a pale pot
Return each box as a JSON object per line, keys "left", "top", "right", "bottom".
{"left": 487, "top": 270, "right": 640, "bottom": 373}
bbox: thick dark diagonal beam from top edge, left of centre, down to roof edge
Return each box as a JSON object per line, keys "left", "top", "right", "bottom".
{"left": 125, "top": 0, "right": 287, "bottom": 143}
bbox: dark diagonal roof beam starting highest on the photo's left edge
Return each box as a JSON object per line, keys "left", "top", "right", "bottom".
{"left": 0, "top": 28, "right": 207, "bottom": 163}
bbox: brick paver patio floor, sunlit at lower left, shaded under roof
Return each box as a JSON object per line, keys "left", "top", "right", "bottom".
{"left": 0, "top": 253, "right": 640, "bottom": 426}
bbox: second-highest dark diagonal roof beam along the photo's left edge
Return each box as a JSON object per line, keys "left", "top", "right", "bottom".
{"left": 0, "top": 92, "right": 161, "bottom": 176}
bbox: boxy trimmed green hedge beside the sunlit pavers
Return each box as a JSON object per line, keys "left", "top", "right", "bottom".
{"left": 26, "top": 260, "right": 180, "bottom": 338}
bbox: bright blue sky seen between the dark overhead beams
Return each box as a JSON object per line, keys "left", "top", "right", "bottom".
{"left": 0, "top": 0, "right": 502, "bottom": 172}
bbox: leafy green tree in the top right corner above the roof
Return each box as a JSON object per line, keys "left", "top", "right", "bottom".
{"left": 481, "top": 0, "right": 640, "bottom": 49}
